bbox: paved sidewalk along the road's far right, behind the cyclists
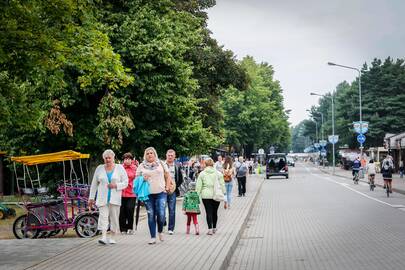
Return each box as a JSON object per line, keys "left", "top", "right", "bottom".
{"left": 314, "top": 163, "right": 405, "bottom": 194}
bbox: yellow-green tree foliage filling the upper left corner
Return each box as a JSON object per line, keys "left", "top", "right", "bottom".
{"left": 0, "top": 0, "right": 133, "bottom": 153}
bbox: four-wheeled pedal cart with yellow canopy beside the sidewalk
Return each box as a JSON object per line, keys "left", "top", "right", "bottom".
{"left": 11, "top": 151, "right": 98, "bottom": 239}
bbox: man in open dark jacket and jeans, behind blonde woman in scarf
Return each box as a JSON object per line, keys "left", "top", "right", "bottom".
{"left": 165, "top": 149, "right": 183, "bottom": 234}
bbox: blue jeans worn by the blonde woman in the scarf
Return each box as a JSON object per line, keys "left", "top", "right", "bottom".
{"left": 145, "top": 192, "right": 167, "bottom": 238}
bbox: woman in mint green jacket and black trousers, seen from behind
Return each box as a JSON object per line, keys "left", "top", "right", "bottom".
{"left": 196, "top": 158, "right": 225, "bottom": 235}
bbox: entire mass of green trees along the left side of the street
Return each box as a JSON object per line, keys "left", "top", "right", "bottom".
{"left": 0, "top": 0, "right": 289, "bottom": 160}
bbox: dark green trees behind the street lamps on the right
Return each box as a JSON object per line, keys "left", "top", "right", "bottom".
{"left": 306, "top": 58, "right": 405, "bottom": 151}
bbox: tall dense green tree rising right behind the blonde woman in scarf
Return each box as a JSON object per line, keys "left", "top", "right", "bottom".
{"left": 98, "top": 1, "right": 219, "bottom": 155}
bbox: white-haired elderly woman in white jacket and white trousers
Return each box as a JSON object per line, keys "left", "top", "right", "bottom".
{"left": 89, "top": 149, "right": 128, "bottom": 245}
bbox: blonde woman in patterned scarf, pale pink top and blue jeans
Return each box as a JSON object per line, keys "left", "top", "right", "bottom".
{"left": 136, "top": 147, "right": 171, "bottom": 245}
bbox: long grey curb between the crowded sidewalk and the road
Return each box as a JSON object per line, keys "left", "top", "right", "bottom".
{"left": 216, "top": 175, "right": 265, "bottom": 270}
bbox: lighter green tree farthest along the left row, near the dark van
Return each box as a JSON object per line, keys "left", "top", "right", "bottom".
{"left": 222, "top": 57, "right": 290, "bottom": 155}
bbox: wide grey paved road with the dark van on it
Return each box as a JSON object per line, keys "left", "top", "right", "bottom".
{"left": 229, "top": 163, "right": 405, "bottom": 270}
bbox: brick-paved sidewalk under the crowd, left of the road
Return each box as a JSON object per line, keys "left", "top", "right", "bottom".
{"left": 21, "top": 176, "right": 264, "bottom": 270}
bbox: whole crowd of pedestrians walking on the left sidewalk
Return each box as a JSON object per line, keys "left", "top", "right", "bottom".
{"left": 89, "top": 147, "right": 254, "bottom": 245}
